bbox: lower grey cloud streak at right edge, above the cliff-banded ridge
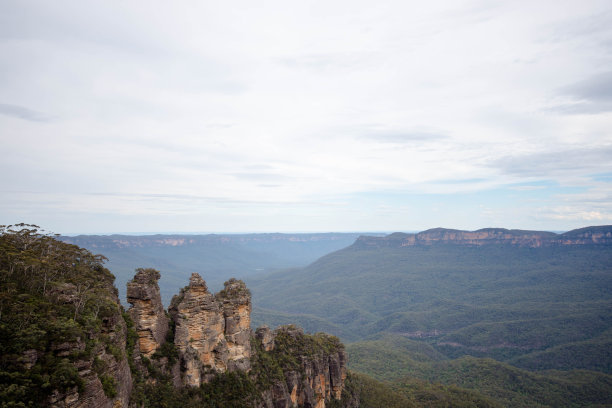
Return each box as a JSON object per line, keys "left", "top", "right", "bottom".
{"left": 489, "top": 146, "right": 612, "bottom": 177}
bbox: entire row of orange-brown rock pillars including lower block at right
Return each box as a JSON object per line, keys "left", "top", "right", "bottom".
{"left": 128, "top": 270, "right": 346, "bottom": 408}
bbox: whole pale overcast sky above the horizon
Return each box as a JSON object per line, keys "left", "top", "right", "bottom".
{"left": 0, "top": 0, "right": 612, "bottom": 234}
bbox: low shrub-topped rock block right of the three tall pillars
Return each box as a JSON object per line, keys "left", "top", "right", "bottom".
{"left": 257, "top": 326, "right": 347, "bottom": 408}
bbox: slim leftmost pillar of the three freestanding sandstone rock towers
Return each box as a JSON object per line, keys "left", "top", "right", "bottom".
{"left": 127, "top": 269, "right": 168, "bottom": 357}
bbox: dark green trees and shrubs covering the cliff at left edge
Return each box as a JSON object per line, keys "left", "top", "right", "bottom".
{"left": 0, "top": 224, "right": 121, "bottom": 406}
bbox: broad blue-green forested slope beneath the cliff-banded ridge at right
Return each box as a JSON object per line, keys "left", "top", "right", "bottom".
{"left": 249, "top": 227, "right": 612, "bottom": 373}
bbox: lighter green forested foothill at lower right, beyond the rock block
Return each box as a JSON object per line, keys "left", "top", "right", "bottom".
{"left": 347, "top": 335, "right": 612, "bottom": 407}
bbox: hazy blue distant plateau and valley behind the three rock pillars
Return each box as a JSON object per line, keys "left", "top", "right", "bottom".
{"left": 60, "top": 233, "right": 372, "bottom": 305}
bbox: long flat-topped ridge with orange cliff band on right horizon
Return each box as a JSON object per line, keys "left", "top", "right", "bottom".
{"left": 353, "top": 225, "right": 612, "bottom": 248}
